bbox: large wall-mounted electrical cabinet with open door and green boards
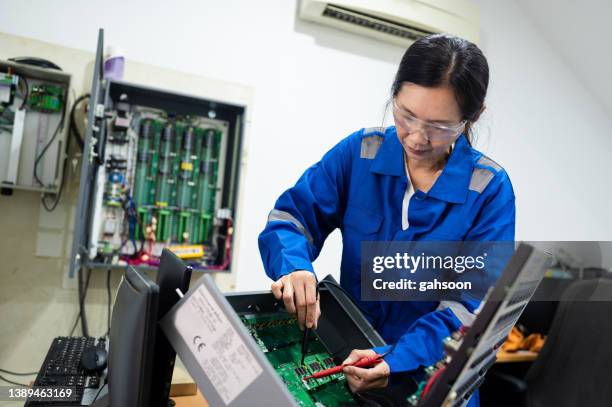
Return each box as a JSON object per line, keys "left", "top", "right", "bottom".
{"left": 70, "top": 30, "right": 245, "bottom": 276}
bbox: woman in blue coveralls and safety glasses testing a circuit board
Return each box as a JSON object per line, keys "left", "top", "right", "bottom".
{"left": 259, "top": 35, "right": 515, "bottom": 403}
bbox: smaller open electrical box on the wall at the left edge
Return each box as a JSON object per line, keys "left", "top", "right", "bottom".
{"left": 0, "top": 61, "right": 71, "bottom": 194}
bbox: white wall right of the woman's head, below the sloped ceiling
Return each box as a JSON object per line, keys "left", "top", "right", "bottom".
{"left": 479, "top": 0, "right": 612, "bottom": 240}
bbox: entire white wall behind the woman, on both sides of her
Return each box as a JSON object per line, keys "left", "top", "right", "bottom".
{"left": 0, "top": 0, "right": 612, "bottom": 302}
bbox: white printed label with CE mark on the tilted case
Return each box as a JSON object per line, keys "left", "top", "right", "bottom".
{"left": 175, "top": 284, "right": 263, "bottom": 404}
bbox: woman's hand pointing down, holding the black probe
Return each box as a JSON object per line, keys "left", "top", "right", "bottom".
{"left": 272, "top": 270, "right": 321, "bottom": 329}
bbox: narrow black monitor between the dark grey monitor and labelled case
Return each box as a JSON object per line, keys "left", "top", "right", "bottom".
{"left": 150, "top": 249, "right": 191, "bottom": 407}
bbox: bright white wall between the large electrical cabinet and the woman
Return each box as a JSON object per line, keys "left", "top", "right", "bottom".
{"left": 0, "top": 0, "right": 403, "bottom": 296}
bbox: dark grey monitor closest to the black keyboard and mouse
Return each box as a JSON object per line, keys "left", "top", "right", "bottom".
{"left": 92, "top": 267, "right": 159, "bottom": 407}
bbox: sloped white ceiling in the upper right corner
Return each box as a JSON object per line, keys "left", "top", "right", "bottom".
{"left": 517, "top": 0, "right": 612, "bottom": 116}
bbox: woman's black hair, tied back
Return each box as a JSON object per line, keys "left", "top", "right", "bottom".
{"left": 391, "top": 34, "right": 489, "bottom": 144}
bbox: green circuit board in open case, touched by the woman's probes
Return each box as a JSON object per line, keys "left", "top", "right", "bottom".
{"left": 241, "top": 311, "right": 356, "bottom": 407}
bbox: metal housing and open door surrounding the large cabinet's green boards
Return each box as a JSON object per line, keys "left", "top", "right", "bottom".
{"left": 69, "top": 30, "right": 246, "bottom": 278}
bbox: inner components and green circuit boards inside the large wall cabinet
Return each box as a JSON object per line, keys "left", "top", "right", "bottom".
{"left": 91, "top": 98, "right": 232, "bottom": 268}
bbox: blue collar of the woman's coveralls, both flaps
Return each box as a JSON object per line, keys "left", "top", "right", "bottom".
{"left": 370, "top": 126, "right": 474, "bottom": 203}
